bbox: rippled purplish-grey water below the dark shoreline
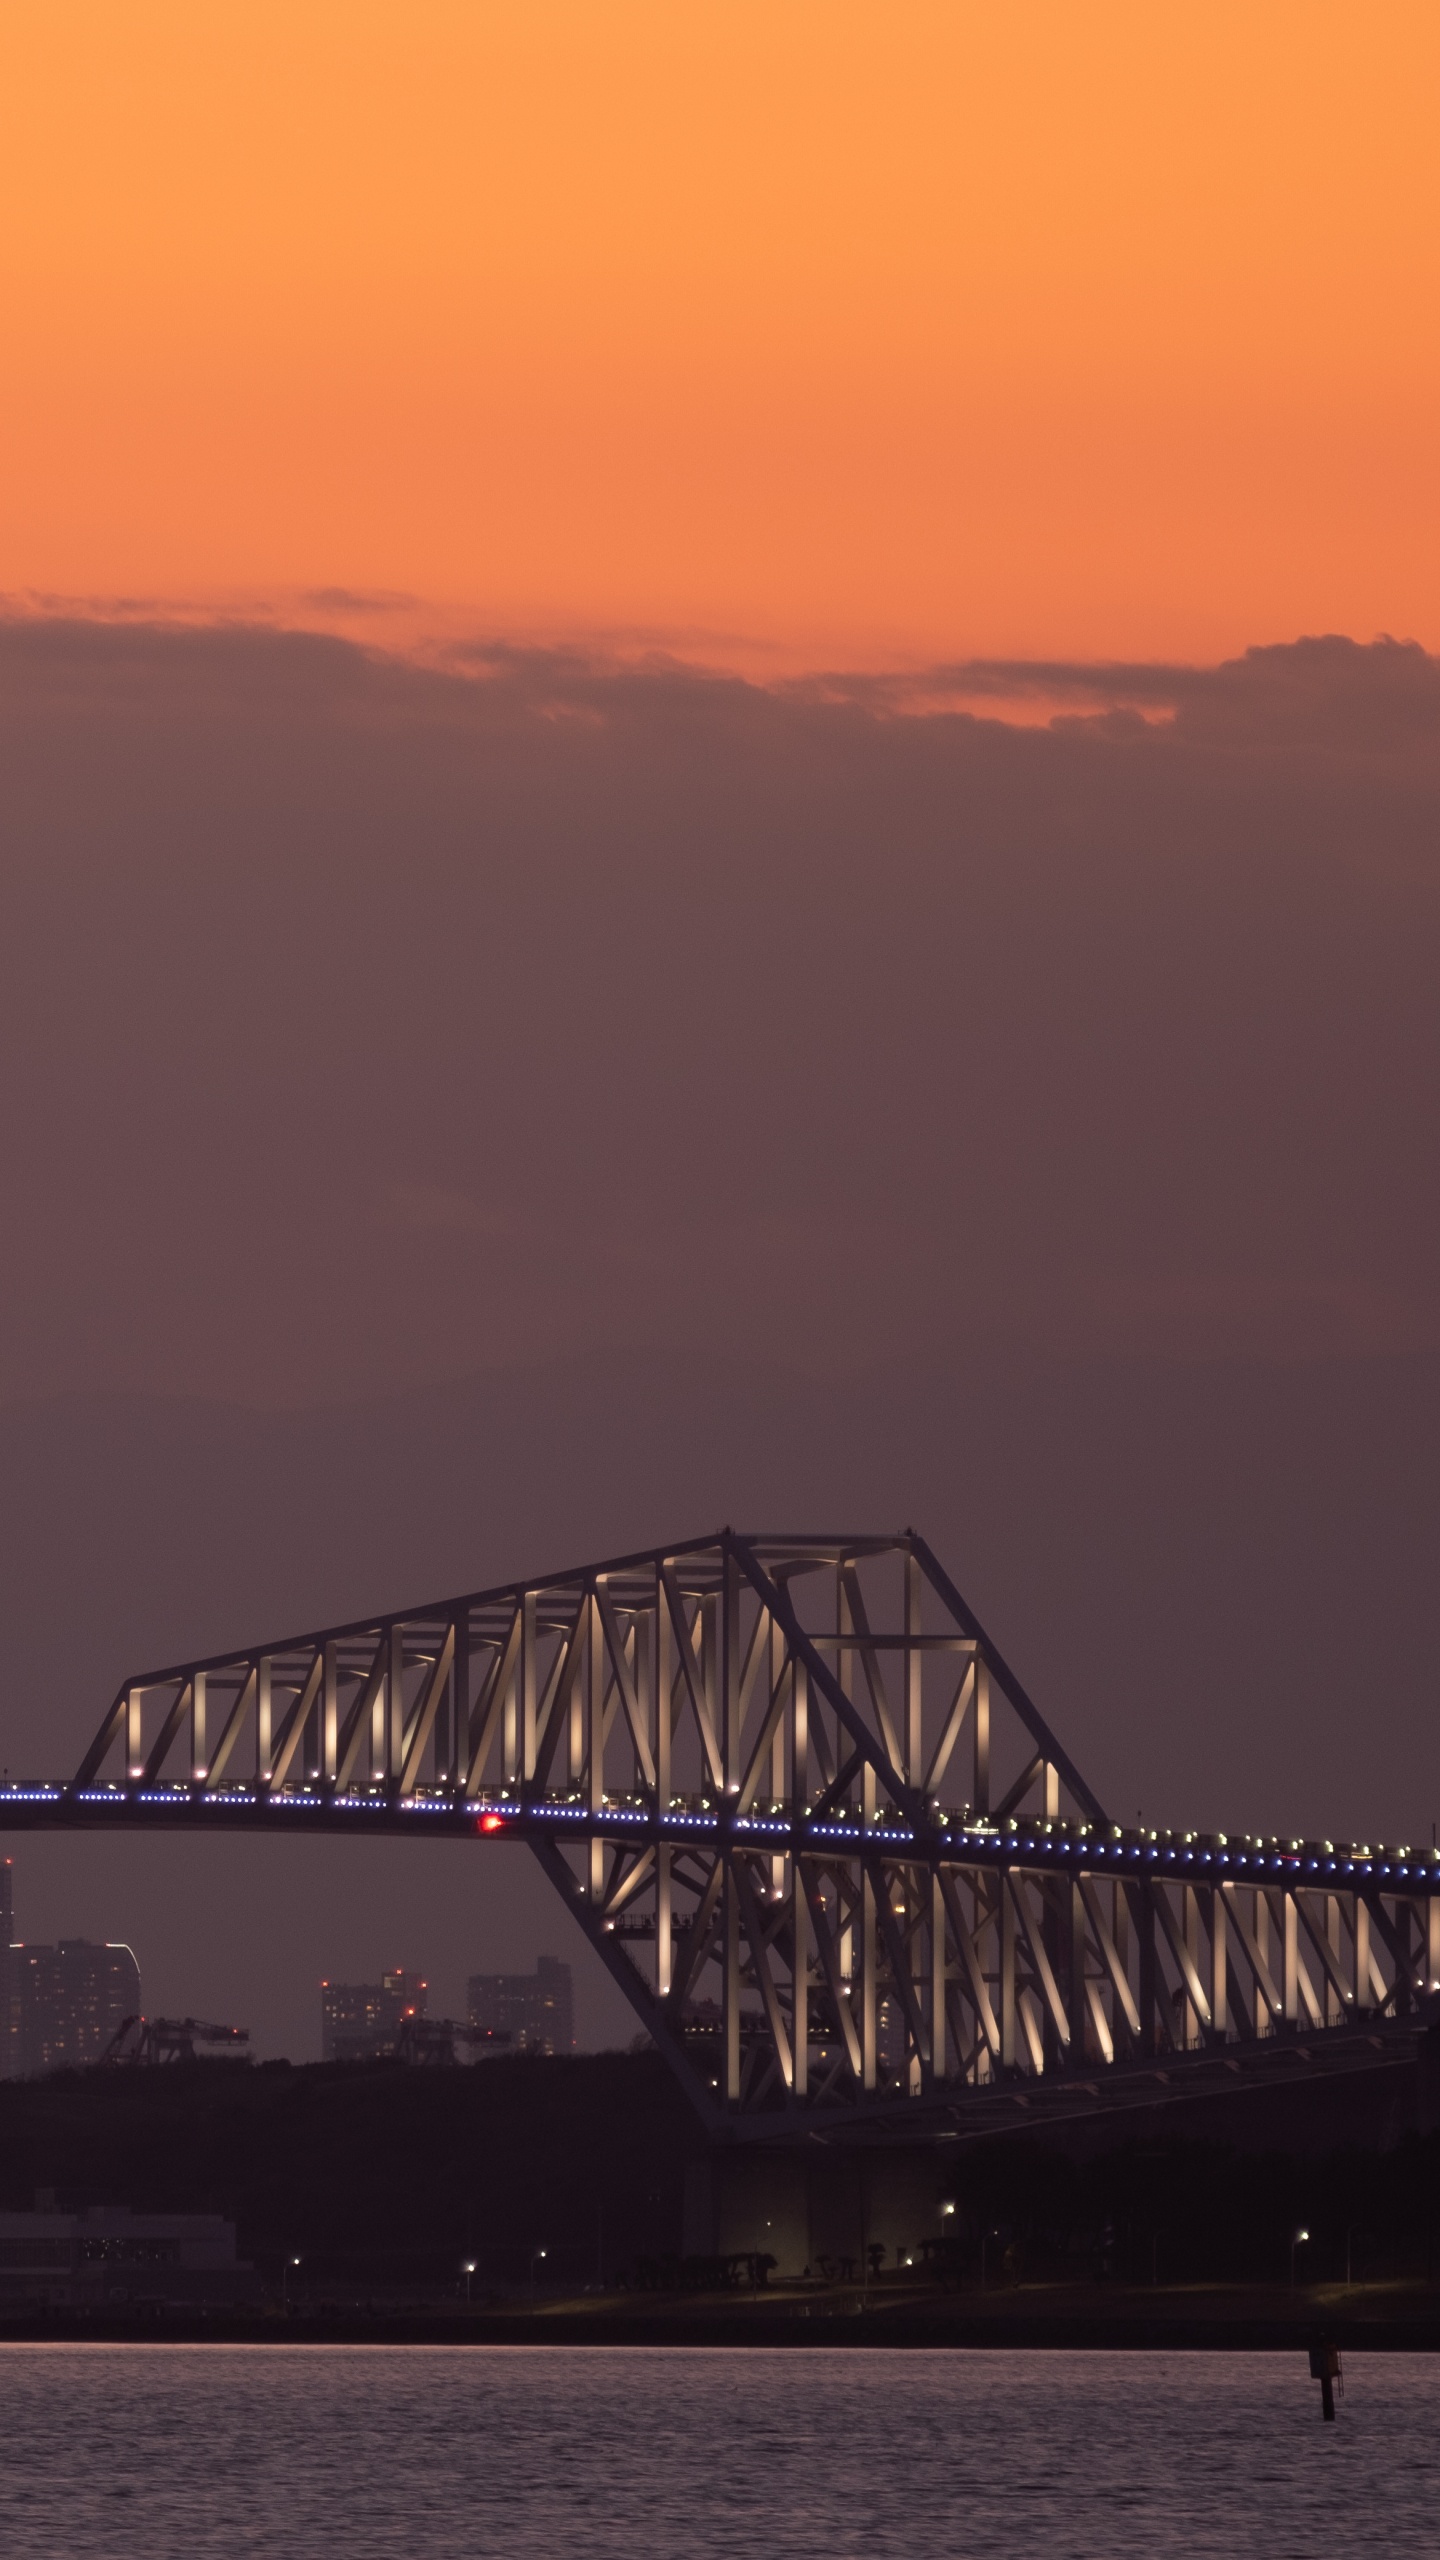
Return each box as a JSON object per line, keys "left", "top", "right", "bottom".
{"left": 0, "top": 2348, "right": 1440, "bottom": 2560}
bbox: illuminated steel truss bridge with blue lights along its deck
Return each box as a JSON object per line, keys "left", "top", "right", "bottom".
{"left": 0, "top": 1528, "right": 1440, "bottom": 2140}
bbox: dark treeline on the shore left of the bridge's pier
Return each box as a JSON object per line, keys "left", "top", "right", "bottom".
{"left": 0, "top": 2053, "right": 700, "bottom": 2296}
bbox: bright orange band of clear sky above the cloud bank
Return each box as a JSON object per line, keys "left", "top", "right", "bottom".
{"left": 0, "top": 0, "right": 1440, "bottom": 663}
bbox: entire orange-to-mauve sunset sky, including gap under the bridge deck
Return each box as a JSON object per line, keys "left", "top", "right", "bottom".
{"left": 0, "top": 0, "right": 1440, "bottom": 2053}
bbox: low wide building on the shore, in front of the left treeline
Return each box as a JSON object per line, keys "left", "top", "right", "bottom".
{"left": 0, "top": 2196, "right": 256, "bottom": 2307}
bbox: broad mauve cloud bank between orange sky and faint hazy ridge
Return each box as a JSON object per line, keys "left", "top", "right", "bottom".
{"left": 0, "top": 604, "right": 1440, "bottom": 1400}
